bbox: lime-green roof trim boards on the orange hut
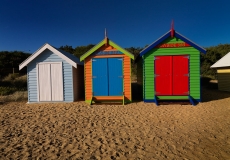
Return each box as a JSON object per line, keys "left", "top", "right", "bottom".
{"left": 80, "top": 37, "right": 134, "bottom": 61}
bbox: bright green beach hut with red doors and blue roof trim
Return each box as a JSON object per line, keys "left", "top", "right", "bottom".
{"left": 135, "top": 27, "right": 206, "bottom": 105}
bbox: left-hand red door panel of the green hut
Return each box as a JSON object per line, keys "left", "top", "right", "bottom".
{"left": 154, "top": 56, "right": 172, "bottom": 95}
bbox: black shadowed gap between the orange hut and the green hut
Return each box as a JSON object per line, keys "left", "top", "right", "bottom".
{"left": 132, "top": 82, "right": 143, "bottom": 102}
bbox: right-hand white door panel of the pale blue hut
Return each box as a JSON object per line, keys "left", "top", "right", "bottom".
{"left": 50, "top": 62, "right": 63, "bottom": 101}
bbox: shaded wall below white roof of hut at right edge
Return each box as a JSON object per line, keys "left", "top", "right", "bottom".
{"left": 217, "top": 68, "right": 230, "bottom": 92}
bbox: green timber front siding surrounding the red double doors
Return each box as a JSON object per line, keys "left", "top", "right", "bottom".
{"left": 143, "top": 38, "right": 200, "bottom": 100}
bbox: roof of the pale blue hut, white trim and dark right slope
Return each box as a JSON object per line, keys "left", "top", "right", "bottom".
{"left": 19, "top": 43, "right": 83, "bottom": 70}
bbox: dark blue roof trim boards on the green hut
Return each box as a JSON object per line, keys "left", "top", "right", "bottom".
{"left": 138, "top": 30, "right": 206, "bottom": 60}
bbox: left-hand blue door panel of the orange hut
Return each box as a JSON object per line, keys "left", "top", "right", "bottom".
{"left": 92, "top": 58, "right": 109, "bottom": 96}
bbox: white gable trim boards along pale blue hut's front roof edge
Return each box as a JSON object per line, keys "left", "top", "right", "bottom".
{"left": 19, "top": 43, "right": 80, "bottom": 70}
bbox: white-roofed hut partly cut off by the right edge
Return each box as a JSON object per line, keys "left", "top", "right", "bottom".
{"left": 211, "top": 52, "right": 230, "bottom": 92}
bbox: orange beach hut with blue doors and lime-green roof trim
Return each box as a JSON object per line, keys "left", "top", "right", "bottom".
{"left": 80, "top": 32, "right": 134, "bottom": 104}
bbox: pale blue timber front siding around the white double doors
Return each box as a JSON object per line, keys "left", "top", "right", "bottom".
{"left": 27, "top": 49, "right": 73, "bottom": 102}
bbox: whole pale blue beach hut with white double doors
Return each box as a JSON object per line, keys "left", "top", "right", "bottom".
{"left": 19, "top": 44, "right": 84, "bottom": 103}
